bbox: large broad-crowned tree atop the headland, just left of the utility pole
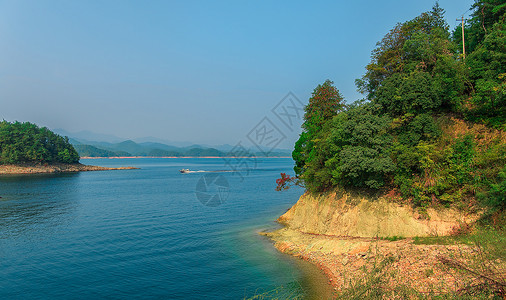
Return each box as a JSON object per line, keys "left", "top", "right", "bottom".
{"left": 357, "top": 4, "right": 467, "bottom": 116}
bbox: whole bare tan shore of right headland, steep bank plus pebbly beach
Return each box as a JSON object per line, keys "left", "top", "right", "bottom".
{"left": 261, "top": 194, "right": 492, "bottom": 295}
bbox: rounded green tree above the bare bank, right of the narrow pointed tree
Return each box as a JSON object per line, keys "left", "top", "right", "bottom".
{"left": 325, "top": 103, "right": 394, "bottom": 189}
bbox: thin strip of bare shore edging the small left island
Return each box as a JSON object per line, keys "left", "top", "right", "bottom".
{"left": 0, "top": 163, "right": 138, "bottom": 174}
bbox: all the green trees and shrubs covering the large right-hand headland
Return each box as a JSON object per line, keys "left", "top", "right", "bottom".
{"left": 293, "top": 0, "right": 506, "bottom": 209}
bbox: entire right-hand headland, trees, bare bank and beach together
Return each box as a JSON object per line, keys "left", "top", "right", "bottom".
{"left": 267, "top": 0, "right": 506, "bottom": 299}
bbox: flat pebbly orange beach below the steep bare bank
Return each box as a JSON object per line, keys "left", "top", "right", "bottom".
{"left": 261, "top": 227, "right": 475, "bottom": 294}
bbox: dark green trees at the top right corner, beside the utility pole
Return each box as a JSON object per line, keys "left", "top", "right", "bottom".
{"left": 453, "top": 0, "right": 506, "bottom": 130}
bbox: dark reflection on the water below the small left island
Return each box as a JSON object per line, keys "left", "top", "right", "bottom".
{"left": 0, "top": 173, "right": 79, "bottom": 239}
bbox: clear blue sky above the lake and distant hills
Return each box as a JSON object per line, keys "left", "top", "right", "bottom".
{"left": 0, "top": 0, "right": 474, "bottom": 148}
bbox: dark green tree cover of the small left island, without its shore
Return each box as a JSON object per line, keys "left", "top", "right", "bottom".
{"left": 0, "top": 121, "right": 79, "bottom": 164}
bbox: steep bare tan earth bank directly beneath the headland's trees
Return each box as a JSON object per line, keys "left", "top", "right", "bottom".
{"left": 278, "top": 193, "right": 479, "bottom": 237}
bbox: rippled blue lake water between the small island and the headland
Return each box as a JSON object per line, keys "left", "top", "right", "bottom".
{"left": 0, "top": 158, "right": 325, "bottom": 299}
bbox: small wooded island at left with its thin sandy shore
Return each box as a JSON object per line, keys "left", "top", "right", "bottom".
{"left": 0, "top": 121, "right": 137, "bottom": 174}
